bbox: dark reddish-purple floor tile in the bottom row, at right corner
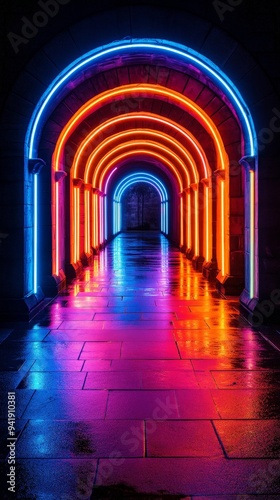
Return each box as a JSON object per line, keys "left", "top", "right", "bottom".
{"left": 95, "top": 457, "right": 280, "bottom": 500}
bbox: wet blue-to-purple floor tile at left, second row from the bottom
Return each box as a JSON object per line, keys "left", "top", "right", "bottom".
{"left": 17, "top": 420, "right": 145, "bottom": 459}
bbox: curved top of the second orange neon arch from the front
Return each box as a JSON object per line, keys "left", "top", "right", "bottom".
{"left": 72, "top": 113, "right": 211, "bottom": 182}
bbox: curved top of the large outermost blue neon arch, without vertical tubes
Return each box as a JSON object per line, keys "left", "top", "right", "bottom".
{"left": 26, "top": 39, "right": 257, "bottom": 158}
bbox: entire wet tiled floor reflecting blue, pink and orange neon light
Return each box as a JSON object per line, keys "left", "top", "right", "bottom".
{"left": 0, "top": 233, "right": 280, "bottom": 500}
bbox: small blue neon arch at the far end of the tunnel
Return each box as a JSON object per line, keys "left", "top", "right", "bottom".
{"left": 113, "top": 172, "right": 168, "bottom": 234}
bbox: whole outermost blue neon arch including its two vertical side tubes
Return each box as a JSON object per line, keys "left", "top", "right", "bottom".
{"left": 26, "top": 40, "right": 257, "bottom": 298}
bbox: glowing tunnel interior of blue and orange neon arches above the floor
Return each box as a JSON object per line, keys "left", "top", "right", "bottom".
{"left": 26, "top": 40, "right": 256, "bottom": 296}
